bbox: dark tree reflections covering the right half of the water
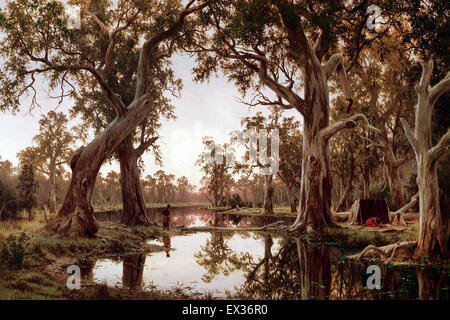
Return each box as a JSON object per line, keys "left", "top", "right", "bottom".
{"left": 196, "top": 232, "right": 449, "bottom": 300}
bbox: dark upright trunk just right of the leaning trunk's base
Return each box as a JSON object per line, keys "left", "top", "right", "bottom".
{"left": 117, "top": 138, "right": 150, "bottom": 226}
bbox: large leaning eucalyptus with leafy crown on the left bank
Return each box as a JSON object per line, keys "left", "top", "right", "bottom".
{"left": 0, "top": 0, "right": 207, "bottom": 236}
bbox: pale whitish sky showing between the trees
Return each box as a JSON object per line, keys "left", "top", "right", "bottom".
{"left": 0, "top": 0, "right": 301, "bottom": 186}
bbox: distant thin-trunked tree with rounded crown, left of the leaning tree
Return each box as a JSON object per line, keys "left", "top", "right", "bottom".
{"left": 18, "top": 111, "right": 79, "bottom": 213}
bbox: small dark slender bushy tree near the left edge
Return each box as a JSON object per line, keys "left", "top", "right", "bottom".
{"left": 17, "top": 163, "right": 38, "bottom": 221}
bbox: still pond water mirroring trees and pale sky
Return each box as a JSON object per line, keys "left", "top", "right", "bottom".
{"left": 93, "top": 208, "right": 450, "bottom": 300}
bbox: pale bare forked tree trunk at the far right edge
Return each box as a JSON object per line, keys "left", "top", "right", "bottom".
{"left": 401, "top": 60, "right": 450, "bottom": 258}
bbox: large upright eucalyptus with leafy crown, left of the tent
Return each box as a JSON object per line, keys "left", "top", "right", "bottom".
{"left": 186, "top": 0, "right": 389, "bottom": 234}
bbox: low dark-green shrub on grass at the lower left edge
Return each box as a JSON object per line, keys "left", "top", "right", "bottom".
{"left": 0, "top": 232, "right": 30, "bottom": 270}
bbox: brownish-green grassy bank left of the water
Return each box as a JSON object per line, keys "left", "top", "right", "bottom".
{"left": 0, "top": 214, "right": 197, "bottom": 300}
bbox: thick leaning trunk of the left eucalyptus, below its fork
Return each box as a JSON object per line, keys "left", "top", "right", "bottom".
{"left": 48, "top": 94, "right": 153, "bottom": 237}
